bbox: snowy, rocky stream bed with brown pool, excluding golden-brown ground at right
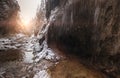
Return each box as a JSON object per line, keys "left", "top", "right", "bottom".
{"left": 0, "top": 34, "right": 59, "bottom": 78}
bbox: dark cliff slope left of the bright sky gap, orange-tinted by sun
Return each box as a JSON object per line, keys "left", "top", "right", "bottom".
{"left": 0, "top": 0, "right": 20, "bottom": 35}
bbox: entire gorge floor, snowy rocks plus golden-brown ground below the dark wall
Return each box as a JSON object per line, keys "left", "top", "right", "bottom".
{"left": 0, "top": 34, "right": 106, "bottom": 78}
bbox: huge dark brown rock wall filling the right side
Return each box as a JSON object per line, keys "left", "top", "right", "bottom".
{"left": 39, "top": 0, "right": 120, "bottom": 78}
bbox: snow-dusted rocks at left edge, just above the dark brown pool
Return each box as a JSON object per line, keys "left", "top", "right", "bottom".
{"left": 0, "top": 34, "right": 25, "bottom": 50}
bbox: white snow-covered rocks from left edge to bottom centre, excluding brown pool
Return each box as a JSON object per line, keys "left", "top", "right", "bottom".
{"left": 0, "top": 31, "right": 59, "bottom": 78}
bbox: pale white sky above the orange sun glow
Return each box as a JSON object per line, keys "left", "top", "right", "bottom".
{"left": 17, "top": 0, "right": 40, "bottom": 23}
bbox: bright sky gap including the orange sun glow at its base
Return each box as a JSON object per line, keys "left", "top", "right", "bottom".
{"left": 17, "top": 0, "right": 41, "bottom": 33}
